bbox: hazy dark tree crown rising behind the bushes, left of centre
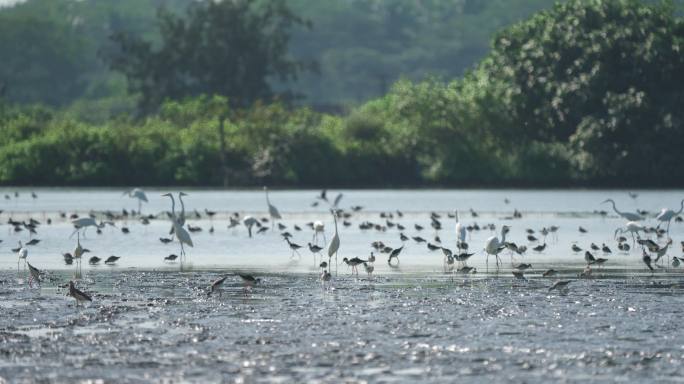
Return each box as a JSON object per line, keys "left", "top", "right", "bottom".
{"left": 111, "top": 0, "right": 312, "bottom": 112}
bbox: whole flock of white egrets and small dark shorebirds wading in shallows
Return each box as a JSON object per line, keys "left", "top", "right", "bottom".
{"left": 0, "top": 187, "right": 684, "bottom": 306}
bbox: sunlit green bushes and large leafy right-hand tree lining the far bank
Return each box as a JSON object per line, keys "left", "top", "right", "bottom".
{"left": 0, "top": 0, "right": 684, "bottom": 187}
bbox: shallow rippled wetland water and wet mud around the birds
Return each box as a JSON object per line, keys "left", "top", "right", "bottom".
{"left": 0, "top": 189, "right": 684, "bottom": 383}
